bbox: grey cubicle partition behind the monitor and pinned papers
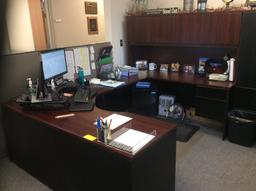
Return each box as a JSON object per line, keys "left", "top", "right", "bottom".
{"left": 0, "top": 42, "right": 110, "bottom": 158}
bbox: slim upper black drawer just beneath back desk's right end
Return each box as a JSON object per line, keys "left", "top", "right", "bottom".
{"left": 196, "top": 87, "right": 228, "bottom": 100}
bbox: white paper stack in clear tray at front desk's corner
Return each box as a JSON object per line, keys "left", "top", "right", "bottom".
{"left": 109, "top": 129, "right": 155, "bottom": 155}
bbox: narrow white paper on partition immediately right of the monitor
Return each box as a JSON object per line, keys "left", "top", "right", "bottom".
{"left": 63, "top": 50, "right": 76, "bottom": 81}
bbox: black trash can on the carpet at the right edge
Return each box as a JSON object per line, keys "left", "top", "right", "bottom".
{"left": 228, "top": 110, "right": 256, "bottom": 147}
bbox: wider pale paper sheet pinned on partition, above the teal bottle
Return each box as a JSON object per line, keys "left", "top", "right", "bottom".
{"left": 74, "top": 47, "right": 91, "bottom": 76}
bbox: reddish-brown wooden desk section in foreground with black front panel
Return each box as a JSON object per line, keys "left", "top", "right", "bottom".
{"left": 3, "top": 102, "right": 176, "bottom": 191}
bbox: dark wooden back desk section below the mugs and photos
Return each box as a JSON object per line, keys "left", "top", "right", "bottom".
{"left": 95, "top": 71, "right": 235, "bottom": 139}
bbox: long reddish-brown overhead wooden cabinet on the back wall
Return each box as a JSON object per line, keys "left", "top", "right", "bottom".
{"left": 127, "top": 12, "right": 242, "bottom": 46}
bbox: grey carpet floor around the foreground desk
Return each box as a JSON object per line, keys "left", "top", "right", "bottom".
{"left": 0, "top": 128, "right": 256, "bottom": 191}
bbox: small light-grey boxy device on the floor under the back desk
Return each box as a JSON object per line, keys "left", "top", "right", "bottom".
{"left": 158, "top": 95, "right": 175, "bottom": 117}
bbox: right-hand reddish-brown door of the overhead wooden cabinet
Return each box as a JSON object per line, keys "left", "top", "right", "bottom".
{"left": 180, "top": 12, "right": 241, "bottom": 45}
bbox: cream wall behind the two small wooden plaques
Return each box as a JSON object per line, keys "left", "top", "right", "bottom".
{"left": 49, "top": 0, "right": 105, "bottom": 47}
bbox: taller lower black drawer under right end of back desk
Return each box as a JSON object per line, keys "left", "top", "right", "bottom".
{"left": 195, "top": 97, "right": 227, "bottom": 121}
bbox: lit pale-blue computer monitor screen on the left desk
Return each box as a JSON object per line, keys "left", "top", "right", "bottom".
{"left": 41, "top": 49, "right": 67, "bottom": 80}
